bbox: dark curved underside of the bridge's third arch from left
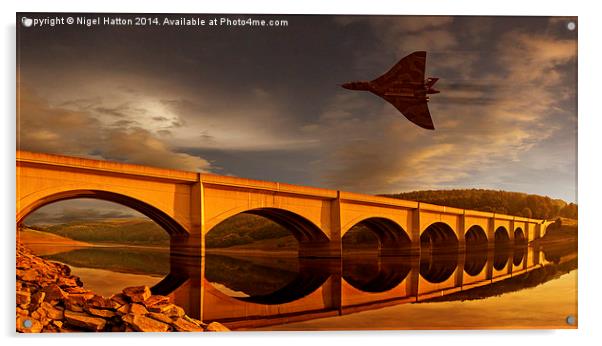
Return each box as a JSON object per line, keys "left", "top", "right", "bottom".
{"left": 342, "top": 217, "right": 412, "bottom": 256}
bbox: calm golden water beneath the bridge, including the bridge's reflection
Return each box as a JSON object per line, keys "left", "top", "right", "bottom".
{"left": 29, "top": 244, "right": 577, "bottom": 330}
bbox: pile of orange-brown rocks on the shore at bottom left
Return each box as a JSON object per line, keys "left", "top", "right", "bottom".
{"left": 16, "top": 245, "right": 228, "bottom": 333}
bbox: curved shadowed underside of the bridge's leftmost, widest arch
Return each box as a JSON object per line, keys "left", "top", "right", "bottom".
{"left": 17, "top": 189, "right": 189, "bottom": 237}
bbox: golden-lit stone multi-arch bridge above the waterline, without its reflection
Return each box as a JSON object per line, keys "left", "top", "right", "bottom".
{"left": 16, "top": 151, "right": 551, "bottom": 257}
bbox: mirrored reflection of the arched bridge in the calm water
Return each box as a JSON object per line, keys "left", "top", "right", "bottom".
{"left": 154, "top": 245, "right": 576, "bottom": 328}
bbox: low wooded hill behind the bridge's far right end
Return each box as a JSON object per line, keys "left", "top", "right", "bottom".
{"left": 384, "top": 189, "right": 577, "bottom": 219}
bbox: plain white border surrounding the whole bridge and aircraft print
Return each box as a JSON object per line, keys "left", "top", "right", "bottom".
{"left": 0, "top": 0, "right": 602, "bottom": 346}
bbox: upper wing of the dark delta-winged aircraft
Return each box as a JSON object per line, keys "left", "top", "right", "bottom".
{"left": 372, "top": 51, "right": 426, "bottom": 87}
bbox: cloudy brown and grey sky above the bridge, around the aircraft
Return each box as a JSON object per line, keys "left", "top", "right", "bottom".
{"left": 17, "top": 14, "right": 578, "bottom": 222}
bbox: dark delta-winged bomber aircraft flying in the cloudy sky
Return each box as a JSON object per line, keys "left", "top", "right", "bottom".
{"left": 341, "top": 51, "right": 439, "bottom": 130}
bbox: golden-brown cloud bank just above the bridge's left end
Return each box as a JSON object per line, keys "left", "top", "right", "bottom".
{"left": 17, "top": 88, "right": 211, "bottom": 171}
